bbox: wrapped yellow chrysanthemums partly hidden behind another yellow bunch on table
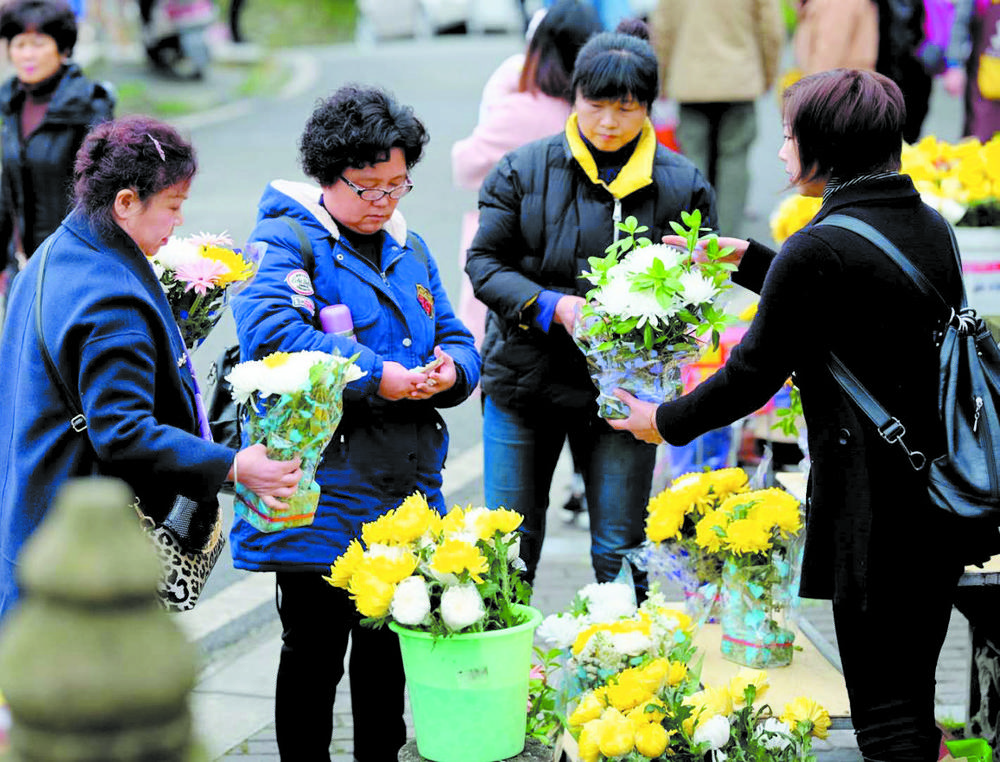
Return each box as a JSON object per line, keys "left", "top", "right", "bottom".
{"left": 629, "top": 468, "right": 749, "bottom": 625}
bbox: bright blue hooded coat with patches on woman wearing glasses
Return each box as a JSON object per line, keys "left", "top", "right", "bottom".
{"left": 231, "top": 180, "right": 479, "bottom": 572}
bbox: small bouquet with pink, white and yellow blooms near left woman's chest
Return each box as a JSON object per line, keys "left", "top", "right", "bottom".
{"left": 150, "top": 233, "right": 265, "bottom": 350}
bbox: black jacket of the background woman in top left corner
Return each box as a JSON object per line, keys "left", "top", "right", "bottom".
{"left": 0, "top": 63, "right": 115, "bottom": 261}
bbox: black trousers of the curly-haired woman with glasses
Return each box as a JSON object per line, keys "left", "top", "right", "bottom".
{"left": 274, "top": 572, "right": 406, "bottom": 762}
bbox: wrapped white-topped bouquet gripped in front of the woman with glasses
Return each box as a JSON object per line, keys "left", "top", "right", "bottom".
{"left": 226, "top": 352, "right": 364, "bottom": 532}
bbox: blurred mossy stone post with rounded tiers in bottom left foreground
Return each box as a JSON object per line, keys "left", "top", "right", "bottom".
{"left": 0, "top": 478, "right": 201, "bottom": 762}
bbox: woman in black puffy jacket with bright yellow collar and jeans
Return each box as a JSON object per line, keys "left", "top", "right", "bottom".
{"left": 466, "top": 25, "right": 715, "bottom": 597}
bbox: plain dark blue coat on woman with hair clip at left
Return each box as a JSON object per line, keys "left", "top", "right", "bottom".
{"left": 0, "top": 212, "right": 235, "bottom": 613}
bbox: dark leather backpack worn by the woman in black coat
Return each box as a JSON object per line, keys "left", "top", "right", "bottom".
{"left": 816, "top": 214, "right": 1000, "bottom": 524}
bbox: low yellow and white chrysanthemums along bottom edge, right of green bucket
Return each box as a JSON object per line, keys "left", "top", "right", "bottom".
{"left": 569, "top": 660, "right": 830, "bottom": 762}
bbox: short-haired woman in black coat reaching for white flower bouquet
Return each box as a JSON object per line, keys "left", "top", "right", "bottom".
{"left": 611, "top": 69, "right": 1000, "bottom": 762}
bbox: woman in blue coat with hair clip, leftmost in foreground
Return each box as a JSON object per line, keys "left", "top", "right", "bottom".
{"left": 0, "top": 117, "right": 302, "bottom": 615}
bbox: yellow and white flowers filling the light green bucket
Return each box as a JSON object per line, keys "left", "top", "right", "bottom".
{"left": 324, "top": 493, "right": 530, "bottom": 636}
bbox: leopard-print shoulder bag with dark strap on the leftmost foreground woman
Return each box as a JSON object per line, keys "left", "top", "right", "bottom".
{"left": 35, "top": 238, "right": 226, "bottom": 611}
